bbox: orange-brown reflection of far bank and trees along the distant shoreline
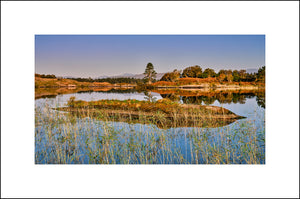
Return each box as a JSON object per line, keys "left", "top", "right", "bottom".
{"left": 35, "top": 87, "right": 265, "bottom": 108}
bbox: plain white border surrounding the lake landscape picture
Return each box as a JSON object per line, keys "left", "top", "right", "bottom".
{"left": 1, "top": 2, "right": 299, "bottom": 197}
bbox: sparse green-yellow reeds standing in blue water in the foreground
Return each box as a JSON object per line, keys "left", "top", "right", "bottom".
{"left": 35, "top": 97, "right": 265, "bottom": 164}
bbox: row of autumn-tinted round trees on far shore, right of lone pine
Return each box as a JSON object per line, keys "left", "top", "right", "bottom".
{"left": 160, "top": 65, "right": 265, "bottom": 82}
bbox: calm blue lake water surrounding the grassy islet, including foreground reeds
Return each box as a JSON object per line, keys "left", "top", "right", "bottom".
{"left": 35, "top": 89, "right": 265, "bottom": 164}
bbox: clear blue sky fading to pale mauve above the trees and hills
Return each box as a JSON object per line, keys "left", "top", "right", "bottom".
{"left": 35, "top": 35, "right": 265, "bottom": 78}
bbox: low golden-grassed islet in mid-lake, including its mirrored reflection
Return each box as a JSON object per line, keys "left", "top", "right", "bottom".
{"left": 54, "top": 97, "right": 245, "bottom": 129}
